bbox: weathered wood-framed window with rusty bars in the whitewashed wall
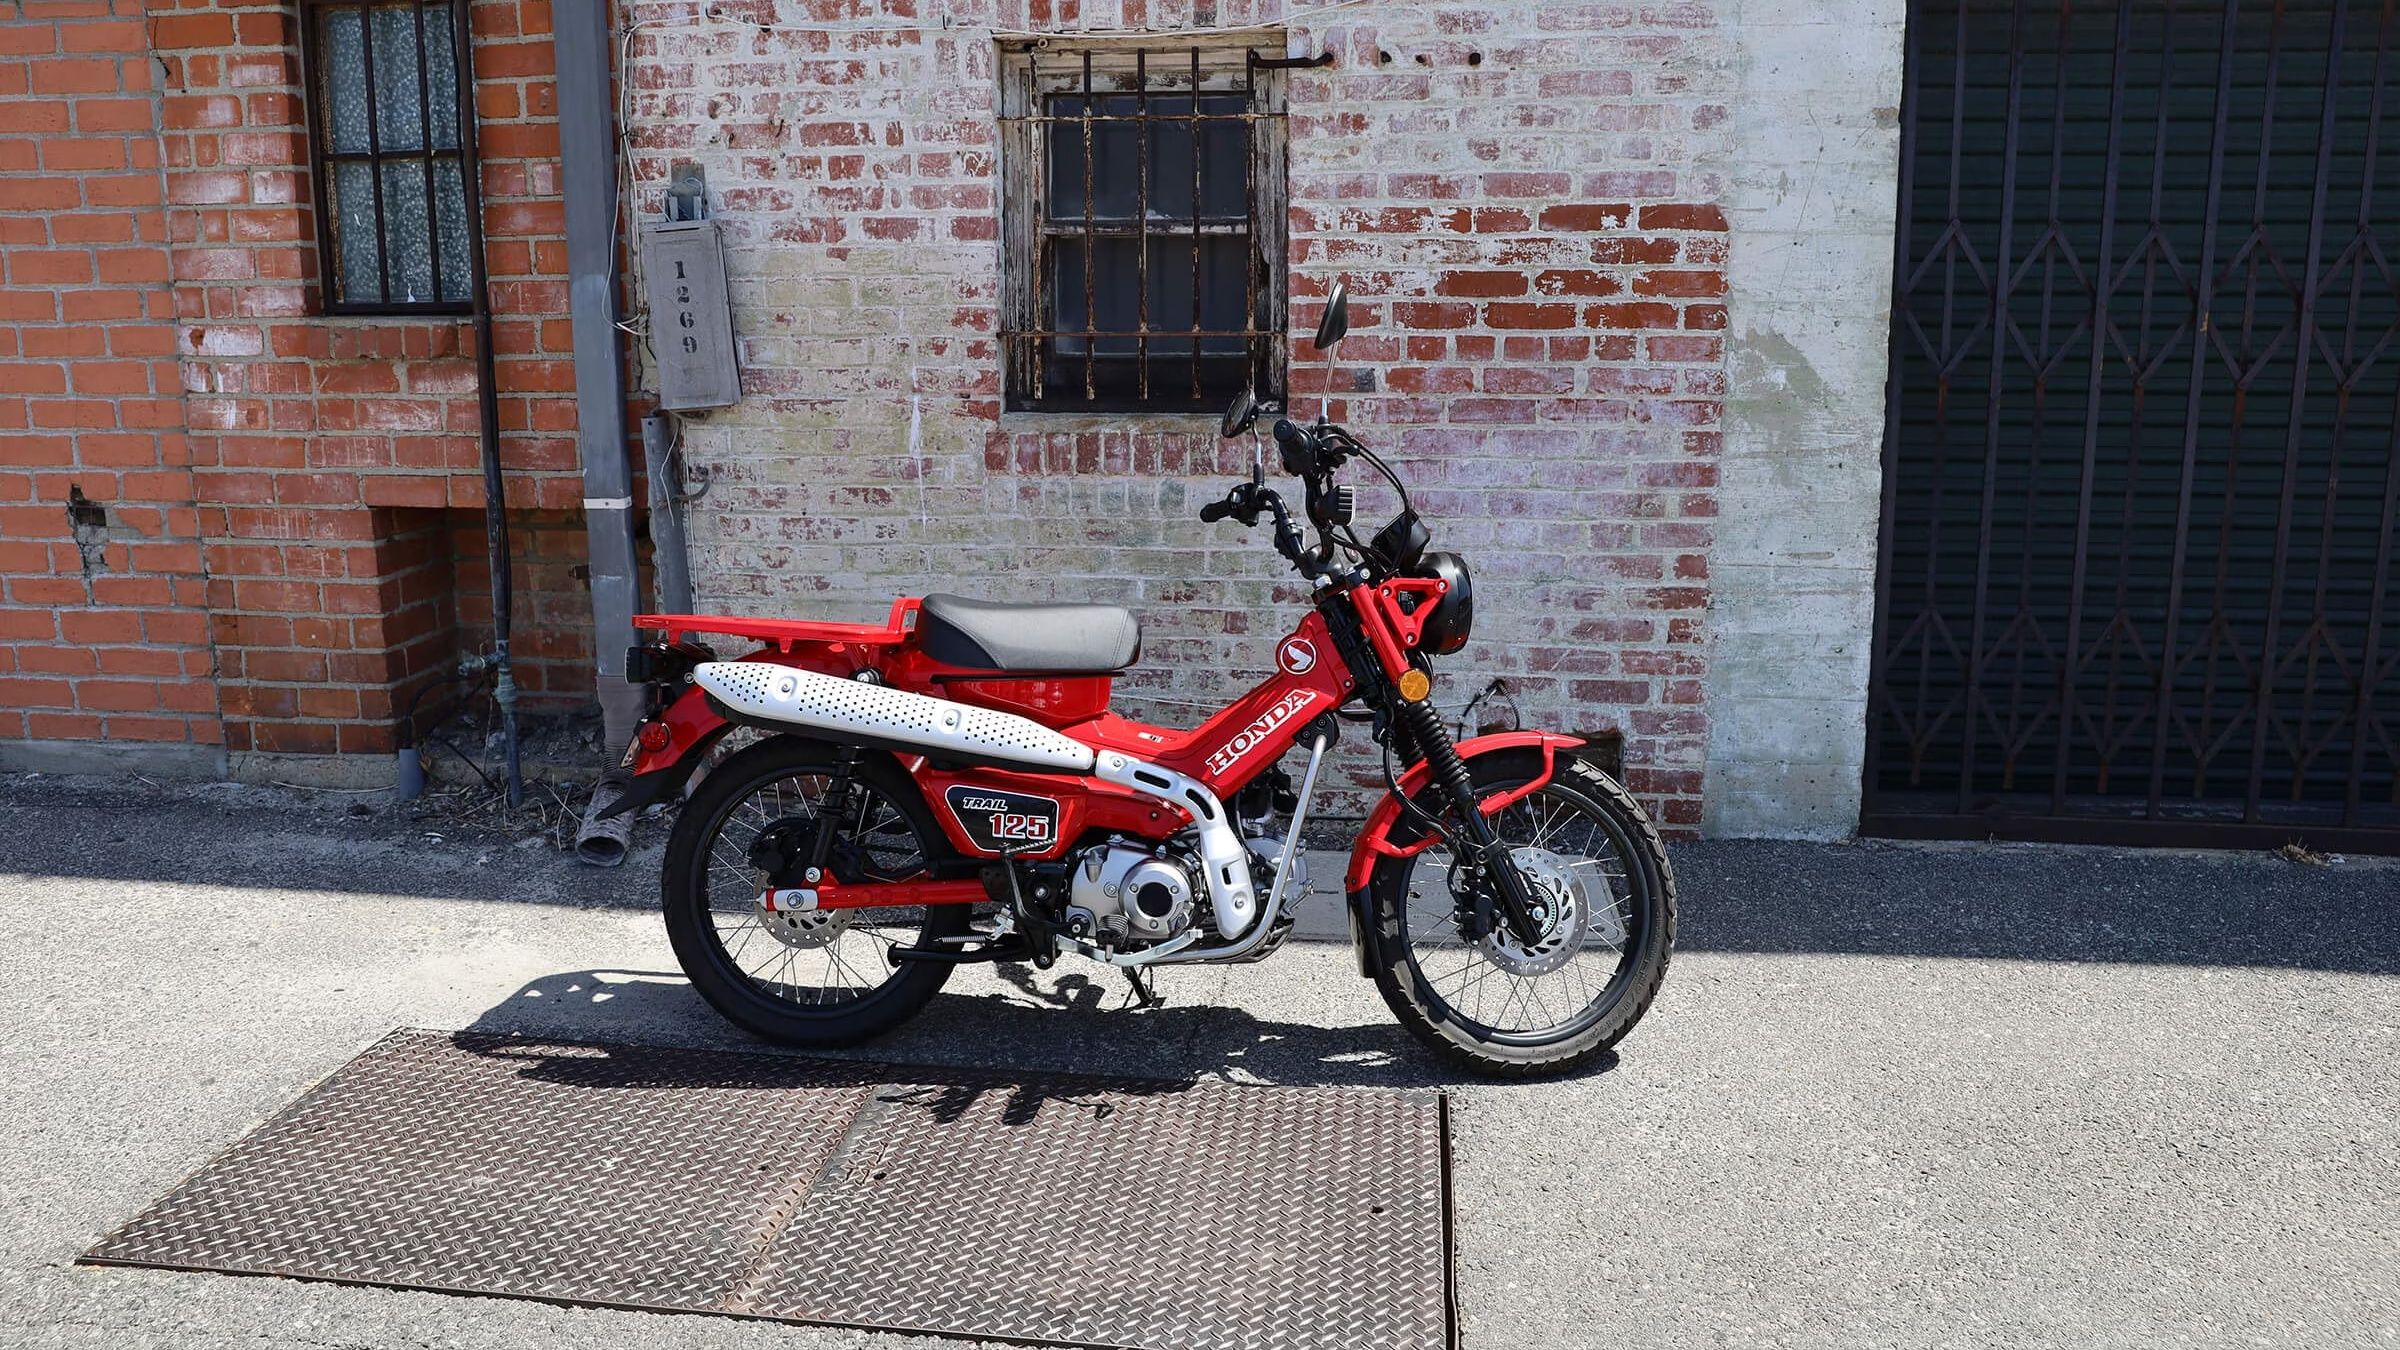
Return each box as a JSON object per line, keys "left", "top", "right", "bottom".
{"left": 1001, "top": 46, "right": 1284, "bottom": 413}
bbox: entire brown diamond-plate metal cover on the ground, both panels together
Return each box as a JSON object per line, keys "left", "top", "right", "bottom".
{"left": 84, "top": 1031, "right": 1454, "bottom": 1350}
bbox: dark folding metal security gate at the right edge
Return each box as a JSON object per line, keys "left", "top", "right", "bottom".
{"left": 1862, "top": 0, "right": 2400, "bottom": 853}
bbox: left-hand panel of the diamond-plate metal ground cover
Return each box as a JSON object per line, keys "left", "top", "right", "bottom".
{"left": 86, "top": 1031, "right": 871, "bottom": 1307}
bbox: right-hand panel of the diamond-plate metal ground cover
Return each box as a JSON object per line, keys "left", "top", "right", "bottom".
{"left": 751, "top": 1066, "right": 1447, "bottom": 1350}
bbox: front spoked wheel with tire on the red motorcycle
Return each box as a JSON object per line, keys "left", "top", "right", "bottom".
{"left": 1368, "top": 757, "right": 1675, "bottom": 1076}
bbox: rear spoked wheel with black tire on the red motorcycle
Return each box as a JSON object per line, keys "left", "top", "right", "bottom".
{"left": 662, "top": 737, "right": 970, "bottom": 1045}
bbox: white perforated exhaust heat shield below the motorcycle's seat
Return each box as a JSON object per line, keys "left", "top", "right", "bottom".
{"left": 691, "top": 661, "right": 1094, "bottom": 773}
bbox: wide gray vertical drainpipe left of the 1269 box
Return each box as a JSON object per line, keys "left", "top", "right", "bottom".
{"left": 552, "top": 0, "right": 641, "bottom": 764}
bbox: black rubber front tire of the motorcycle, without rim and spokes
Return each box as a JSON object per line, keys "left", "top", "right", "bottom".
{"left": 1368, "top": 754, "right": 1675, "bottom": 1079}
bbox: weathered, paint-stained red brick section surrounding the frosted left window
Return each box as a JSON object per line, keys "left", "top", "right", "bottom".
{"left": 151, "top": 0, "right": 590, "bottom": 752}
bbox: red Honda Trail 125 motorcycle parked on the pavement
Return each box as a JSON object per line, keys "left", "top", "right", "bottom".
{"left": 614, "top": 286, "right": 1675, "bottom": 1074}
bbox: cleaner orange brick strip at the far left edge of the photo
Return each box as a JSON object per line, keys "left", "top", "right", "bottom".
{"left": 0, "top": 0, "right": 223, "bottom": 747}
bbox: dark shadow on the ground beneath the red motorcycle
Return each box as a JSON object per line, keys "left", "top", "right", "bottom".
{"left": 466, "top": 966, "right": 1615, "bottom": 1091}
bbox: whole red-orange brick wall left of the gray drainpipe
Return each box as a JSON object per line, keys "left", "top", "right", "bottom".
{"left": 0, "top": 0, "right": 590, "bottom": 771}
